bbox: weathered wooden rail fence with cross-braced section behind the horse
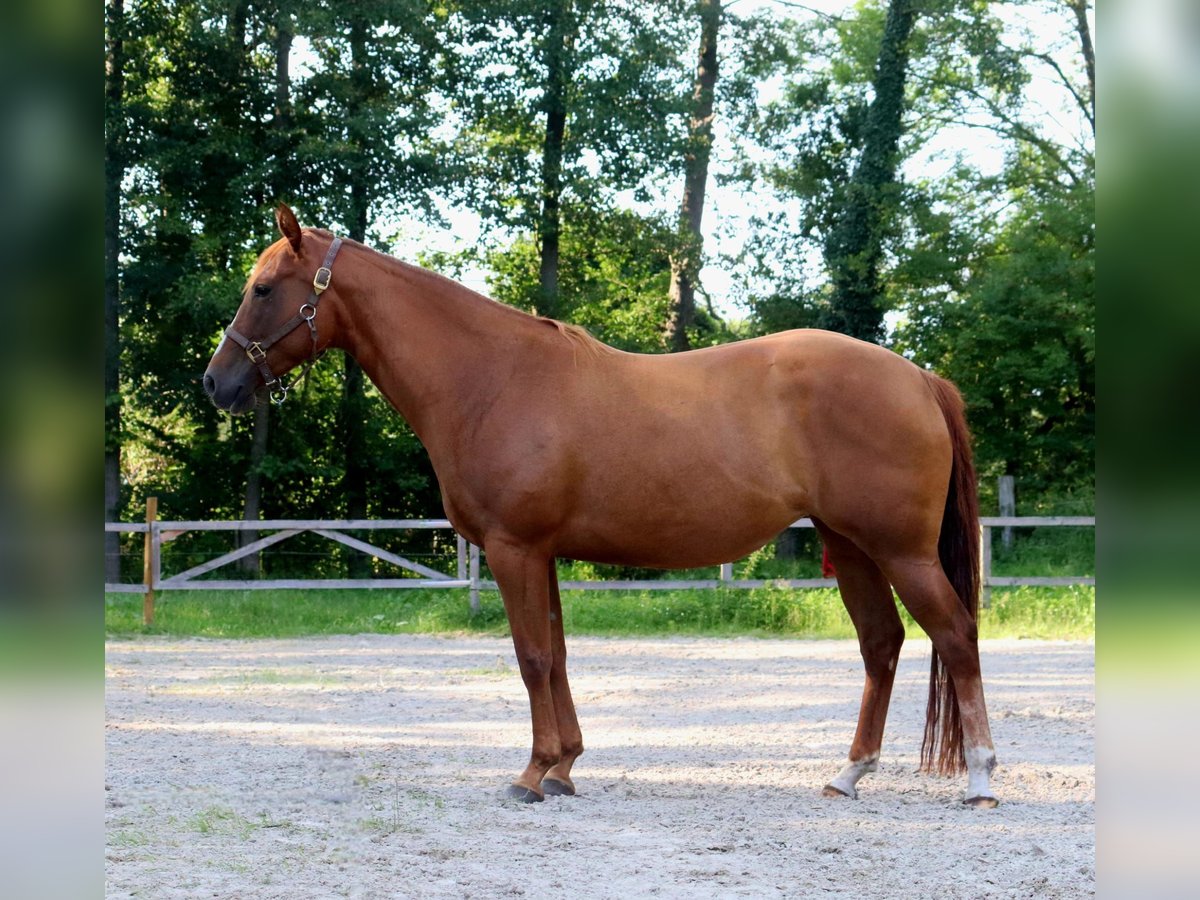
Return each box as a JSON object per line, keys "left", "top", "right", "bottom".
{"left": 104, "top": 498, "right": 1096, "bottom": 624}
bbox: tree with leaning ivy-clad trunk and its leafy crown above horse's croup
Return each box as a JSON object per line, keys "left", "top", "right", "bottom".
{"left": 739, "top": 0, "right": 1025, "bottom": 340}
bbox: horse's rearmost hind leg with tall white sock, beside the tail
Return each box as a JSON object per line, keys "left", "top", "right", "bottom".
{"left": 883, "top": 560, "right": 998, "bottom": 808}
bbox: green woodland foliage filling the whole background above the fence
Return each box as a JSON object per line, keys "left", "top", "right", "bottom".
{"left": 106, "top": 0, "right": 1094, "bottom": 547}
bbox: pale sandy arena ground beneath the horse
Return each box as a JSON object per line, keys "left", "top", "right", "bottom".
{"left": 104, "top": 635, "right": 1096, "bottom": 898}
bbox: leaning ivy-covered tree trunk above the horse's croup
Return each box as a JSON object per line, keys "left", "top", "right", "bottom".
{"left": 821, "top": 0, "right": 917, "bottom": 342}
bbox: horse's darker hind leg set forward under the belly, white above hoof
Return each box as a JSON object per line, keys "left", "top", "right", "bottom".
{"left": 816, "top": 522, "right": 904, "bottom": 797}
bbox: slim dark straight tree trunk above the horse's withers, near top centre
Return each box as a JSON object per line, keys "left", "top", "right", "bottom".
{"left": 536, "top": 0, "right": 572, "bottom": 317}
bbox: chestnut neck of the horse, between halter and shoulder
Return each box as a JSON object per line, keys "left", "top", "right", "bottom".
{"left": 335, "top": 248, "right": 547, "bottom": 451}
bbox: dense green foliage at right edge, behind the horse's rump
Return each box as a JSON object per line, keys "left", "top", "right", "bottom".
{"left": 898, "top": 161, "right": 1096, "bottom": 493}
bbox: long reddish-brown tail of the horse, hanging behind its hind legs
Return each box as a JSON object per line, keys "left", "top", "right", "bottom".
{"left": 920, "top": 372, "right": 979, "bottom": 775}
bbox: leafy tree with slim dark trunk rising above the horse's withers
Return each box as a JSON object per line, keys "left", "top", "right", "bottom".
{"left": 452, "top": 0, "right": 685, "bottom": 317}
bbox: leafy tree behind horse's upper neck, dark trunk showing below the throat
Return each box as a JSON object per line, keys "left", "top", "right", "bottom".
{"left": 301, "top": 0, "right": 456, "bottom": 556}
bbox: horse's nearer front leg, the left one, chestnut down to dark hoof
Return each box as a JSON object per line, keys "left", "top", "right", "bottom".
{"left": 485, "top": 540, "right": 563, "bottom": 803}
